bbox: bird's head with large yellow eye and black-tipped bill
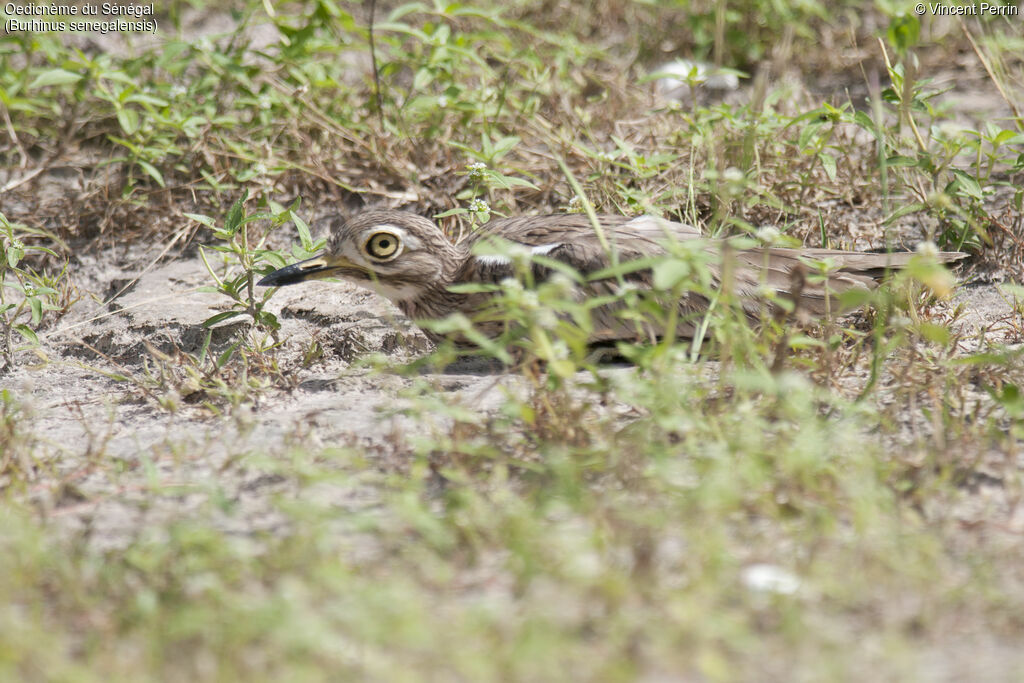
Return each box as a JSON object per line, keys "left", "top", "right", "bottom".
{"left": 259, "top": 211, "right": 457, "bottom": 301}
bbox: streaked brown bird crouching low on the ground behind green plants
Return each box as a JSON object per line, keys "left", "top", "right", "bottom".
{"left": 258, "top": 210, "right": 967, "bottom": 346}
